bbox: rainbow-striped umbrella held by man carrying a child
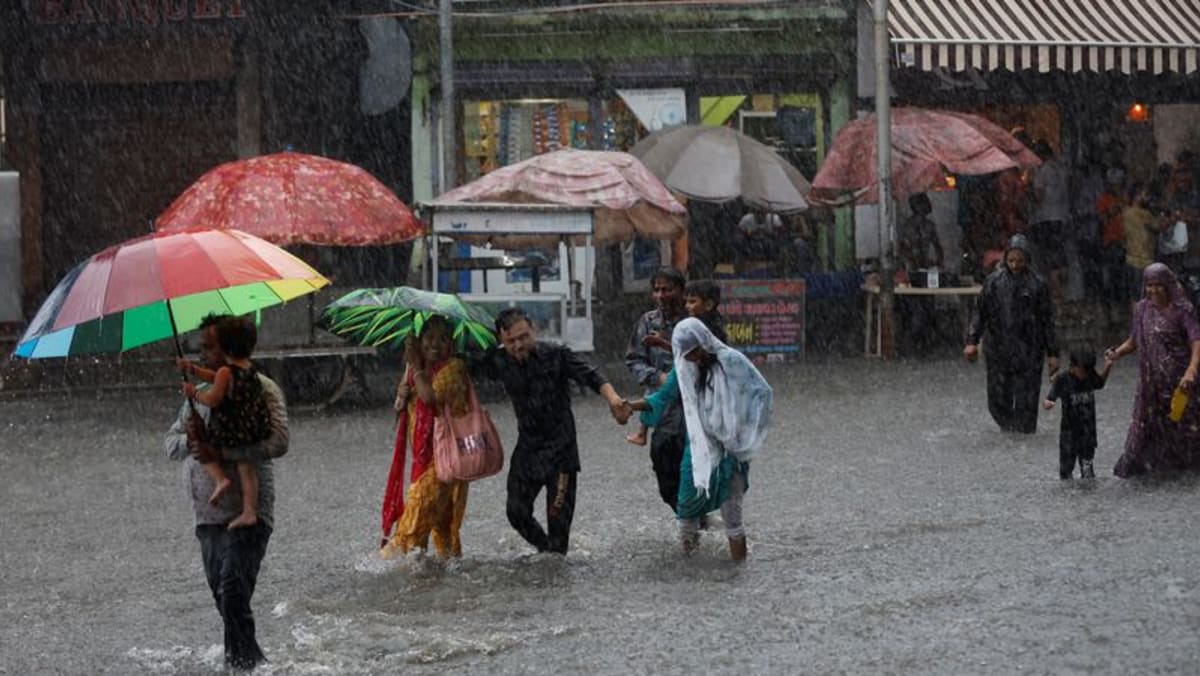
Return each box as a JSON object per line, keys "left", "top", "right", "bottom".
{"left": 13, "top": 228, "right": 329, "bottom": 359}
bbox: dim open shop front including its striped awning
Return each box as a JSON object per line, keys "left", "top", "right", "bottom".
{"left": 859, "top": 0, "right": 1200, "bottom": 278}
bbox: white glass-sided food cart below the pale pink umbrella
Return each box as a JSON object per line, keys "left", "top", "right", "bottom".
{"left": 422, "top": 201, "right": 595, "bottom": 352}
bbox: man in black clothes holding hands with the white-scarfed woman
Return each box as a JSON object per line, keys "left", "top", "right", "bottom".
{"left": 473, "top": 309, "right": 631, "bottom": 554}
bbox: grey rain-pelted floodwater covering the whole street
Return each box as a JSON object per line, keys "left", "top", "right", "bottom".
{"left": 0, "top": 360, "right": 1200, "bottom": 675}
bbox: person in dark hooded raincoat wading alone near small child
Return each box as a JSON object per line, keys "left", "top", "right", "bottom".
{"left": 962, "top": 234, "right": 1058, "bottom": 433}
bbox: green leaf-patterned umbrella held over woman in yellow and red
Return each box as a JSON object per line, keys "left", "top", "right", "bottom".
{"left": 318, "top": 286, "right": 496, "bottom": 351}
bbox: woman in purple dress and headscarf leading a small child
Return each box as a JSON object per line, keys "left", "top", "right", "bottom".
{"left": 1105, "top": 263, "right": 1200, "bottom": 478}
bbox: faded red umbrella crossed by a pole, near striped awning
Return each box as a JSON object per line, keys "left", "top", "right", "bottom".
{"left": 812, "top": 108, "right": 1042, "bottom": 203}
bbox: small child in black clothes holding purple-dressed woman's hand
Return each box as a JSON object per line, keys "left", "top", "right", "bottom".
{"left": 1042, "top": 349, "right": 1112, "bottom": 479}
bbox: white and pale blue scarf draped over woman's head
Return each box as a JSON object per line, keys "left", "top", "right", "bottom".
{"left": 671, "top": 317, "right": 772, "bottom": 493}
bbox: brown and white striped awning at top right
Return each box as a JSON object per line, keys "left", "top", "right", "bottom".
{"left": 888, "top": 0, "right": 1200, "bottom": 73}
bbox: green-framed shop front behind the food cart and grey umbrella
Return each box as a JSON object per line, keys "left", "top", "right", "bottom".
{"left": 410, "top": 1, "right": 853, "bottom": 352}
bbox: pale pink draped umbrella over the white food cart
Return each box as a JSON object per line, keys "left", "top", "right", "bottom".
{"left": 432, "top": 150, "right": 688, "bottom": 244}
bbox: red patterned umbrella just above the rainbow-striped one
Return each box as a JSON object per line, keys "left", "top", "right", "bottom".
{"left": 155, "top": 151, "right": 425, "bottom": 246}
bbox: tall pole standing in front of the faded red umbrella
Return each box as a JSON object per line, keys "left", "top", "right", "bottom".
{"left": 872, "top": 0, "right": 896, "bottom": 359}
